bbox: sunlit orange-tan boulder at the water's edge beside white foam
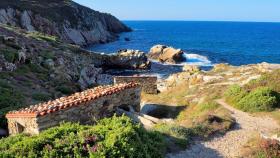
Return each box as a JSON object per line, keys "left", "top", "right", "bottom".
{"left": 148, "top": 45, "right": 186, "bottom": 64}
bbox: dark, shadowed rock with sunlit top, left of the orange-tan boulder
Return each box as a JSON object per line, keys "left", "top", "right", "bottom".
{"left": 107, "top": 49, "right": 151, "bottom": 69}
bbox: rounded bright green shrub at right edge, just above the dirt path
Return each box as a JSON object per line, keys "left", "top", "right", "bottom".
{"left": 237, "top": 87, "right": 279, "bottom": 112}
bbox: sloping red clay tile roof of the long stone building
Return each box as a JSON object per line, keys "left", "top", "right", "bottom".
{"left": 6, "top": 83, "right": 139, "bottom": 118}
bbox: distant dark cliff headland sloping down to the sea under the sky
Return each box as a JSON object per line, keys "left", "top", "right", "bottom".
{"left": 0, "top": 0, "right": 131, "bottom": 45}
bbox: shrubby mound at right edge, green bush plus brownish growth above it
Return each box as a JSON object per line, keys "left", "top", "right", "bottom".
{"left": 225, "top": 70, "right": 280, "bottom": 112}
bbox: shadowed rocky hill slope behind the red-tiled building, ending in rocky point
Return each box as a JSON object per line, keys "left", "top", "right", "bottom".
{"left": 0, "top": 24, "right": 149, "bottom": 129}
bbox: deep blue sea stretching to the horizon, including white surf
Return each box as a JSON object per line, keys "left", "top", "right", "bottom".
{"left": 88, "top": 21, "right": 280, "bottom": 66}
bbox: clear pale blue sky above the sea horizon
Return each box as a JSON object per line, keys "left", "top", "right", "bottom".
{"left": 74, "top": 0, "right": 280, "bottom": 22}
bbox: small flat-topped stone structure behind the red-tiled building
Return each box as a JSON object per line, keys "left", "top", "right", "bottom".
{"left": 114, "top": 76, "right": 158, "bottom": 94}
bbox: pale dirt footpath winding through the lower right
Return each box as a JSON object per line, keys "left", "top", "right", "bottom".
{"left": 167, "top": 99, "right": 279, "bottom": 158}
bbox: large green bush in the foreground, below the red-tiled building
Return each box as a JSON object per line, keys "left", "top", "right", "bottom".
{"left": 0, "top": 116, "right": 165, "bottom": 158}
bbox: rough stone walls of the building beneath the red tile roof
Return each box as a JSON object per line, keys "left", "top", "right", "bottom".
{"left": 6, "top": 86, "right": 141, "bottom": 135}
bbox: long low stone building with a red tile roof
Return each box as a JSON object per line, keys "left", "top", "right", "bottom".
{"left": 6, "top": 83, "right": 141, "bottom": 135}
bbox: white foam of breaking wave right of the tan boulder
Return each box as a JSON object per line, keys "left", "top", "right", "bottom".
{"left": 182, "top": 53, "right": 212, "bottom": 66}
